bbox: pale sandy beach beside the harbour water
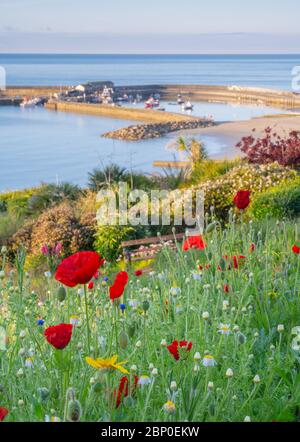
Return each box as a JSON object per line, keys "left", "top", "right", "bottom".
{"left": 182, "top": 115, "right": 300, "bottom": 159}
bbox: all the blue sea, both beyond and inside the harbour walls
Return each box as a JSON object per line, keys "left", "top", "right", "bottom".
{"left": 0, "top": 54, "right": 300, "bottom": 192}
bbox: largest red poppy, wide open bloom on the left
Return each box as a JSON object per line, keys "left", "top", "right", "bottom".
{"left": 55, "top": 252, "right": 104, "bottom": 287}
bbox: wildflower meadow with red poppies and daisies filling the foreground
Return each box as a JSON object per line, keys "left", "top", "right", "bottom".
{"left": 0, "top": 204, "right": 300, "bottom": 422}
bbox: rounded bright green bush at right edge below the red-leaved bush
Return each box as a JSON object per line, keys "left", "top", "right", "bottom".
{"left": 251, "top": 177, "right": 300, "bottom": 220}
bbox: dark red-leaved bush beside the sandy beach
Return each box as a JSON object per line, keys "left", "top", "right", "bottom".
{"left": 237, "top": 127, "right": 300, "bottom": 167}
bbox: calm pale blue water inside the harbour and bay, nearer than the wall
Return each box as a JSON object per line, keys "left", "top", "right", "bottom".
{"left": 0, "top": 103, "right": 290, "bottom": 191}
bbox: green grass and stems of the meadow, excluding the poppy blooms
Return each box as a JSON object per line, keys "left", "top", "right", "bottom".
{"left": 0, "top": 217, "right": 300, "bottom": 422}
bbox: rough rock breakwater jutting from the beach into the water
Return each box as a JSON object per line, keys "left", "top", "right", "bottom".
{"left": 102, "top": 119, "right": 214, "bottom": 141}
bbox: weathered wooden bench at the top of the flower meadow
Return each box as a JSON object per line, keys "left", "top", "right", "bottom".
{"left": 121, "top": 233, "right": 185, "bottom": 264}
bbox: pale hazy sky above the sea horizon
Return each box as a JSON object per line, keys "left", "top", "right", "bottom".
{"left": 0, "top": 0, "right": 300, "bottom": 53}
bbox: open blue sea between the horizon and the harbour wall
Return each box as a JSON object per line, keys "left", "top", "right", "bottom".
{"left": 0, "top": 54, "right": 300, "bottom": 90}
